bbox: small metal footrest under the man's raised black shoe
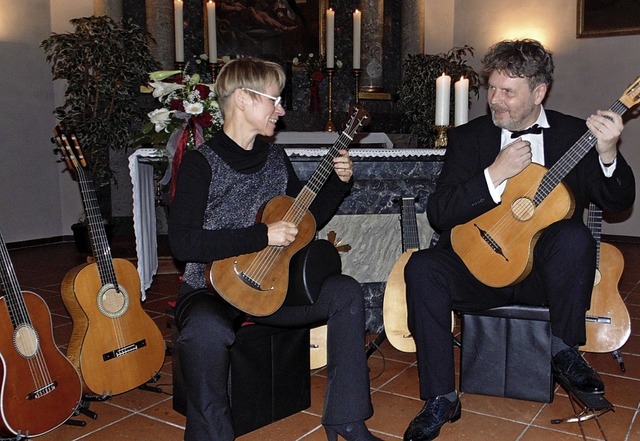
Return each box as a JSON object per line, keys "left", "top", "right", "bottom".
{"left": 551, "top": 376, "right": 615, "bottom": 441}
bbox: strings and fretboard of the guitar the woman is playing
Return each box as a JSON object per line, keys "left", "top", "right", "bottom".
{"left": 244, "top": 126, "right": 353, "bottom": 285}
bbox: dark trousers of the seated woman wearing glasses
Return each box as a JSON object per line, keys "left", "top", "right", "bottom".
{"left": 176, "top": 274, "right": 373, "bottom": 441}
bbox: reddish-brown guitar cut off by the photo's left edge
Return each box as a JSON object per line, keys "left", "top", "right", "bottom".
{"left": 0, "top": 227, "right": 82, "bottom": 439}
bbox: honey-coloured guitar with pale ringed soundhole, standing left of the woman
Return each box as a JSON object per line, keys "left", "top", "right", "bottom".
{"left": 54, "top": 126, "right": 165, "bottom": 395}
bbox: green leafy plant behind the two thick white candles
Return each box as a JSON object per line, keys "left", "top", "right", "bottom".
{"left": 398, "top": 45, "right": 480, "bottom": 146}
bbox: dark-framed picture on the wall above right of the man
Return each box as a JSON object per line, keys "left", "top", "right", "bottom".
{"left": 576, "top": 0, "right": 640, "bottom": 38}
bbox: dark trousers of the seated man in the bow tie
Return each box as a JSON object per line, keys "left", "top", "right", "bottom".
{"left": 405, "top": 220, "right": 596, "bottom": 400}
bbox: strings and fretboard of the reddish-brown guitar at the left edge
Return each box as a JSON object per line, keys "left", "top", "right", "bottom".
{"left": 0, "top": 233, "right": 53, "bottom": 390}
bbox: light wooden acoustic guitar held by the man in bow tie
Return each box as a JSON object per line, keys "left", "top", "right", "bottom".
{"left": 451, "top": 77, "right": 640, "bottom": 288}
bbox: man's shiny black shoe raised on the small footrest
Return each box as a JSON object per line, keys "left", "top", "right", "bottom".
{"left": 551, "top": 348, "right": 604, "bottom": 394}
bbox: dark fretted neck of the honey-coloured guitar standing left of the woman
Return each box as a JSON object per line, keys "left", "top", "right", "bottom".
{"left": 77, "top": 168, "right": 118, "bottom": 286}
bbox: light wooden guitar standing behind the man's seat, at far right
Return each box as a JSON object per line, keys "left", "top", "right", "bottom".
{"left": 580, "top": 203, "right": 631, "bottom": 352}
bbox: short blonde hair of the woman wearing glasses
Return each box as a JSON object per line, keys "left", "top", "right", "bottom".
{"left": 216, "top": 57, "right": 286, "bottom": 116}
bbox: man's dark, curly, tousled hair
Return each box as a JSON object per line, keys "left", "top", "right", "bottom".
{"left": 482, "top": 39, "right": 553, "bottom": 90}
